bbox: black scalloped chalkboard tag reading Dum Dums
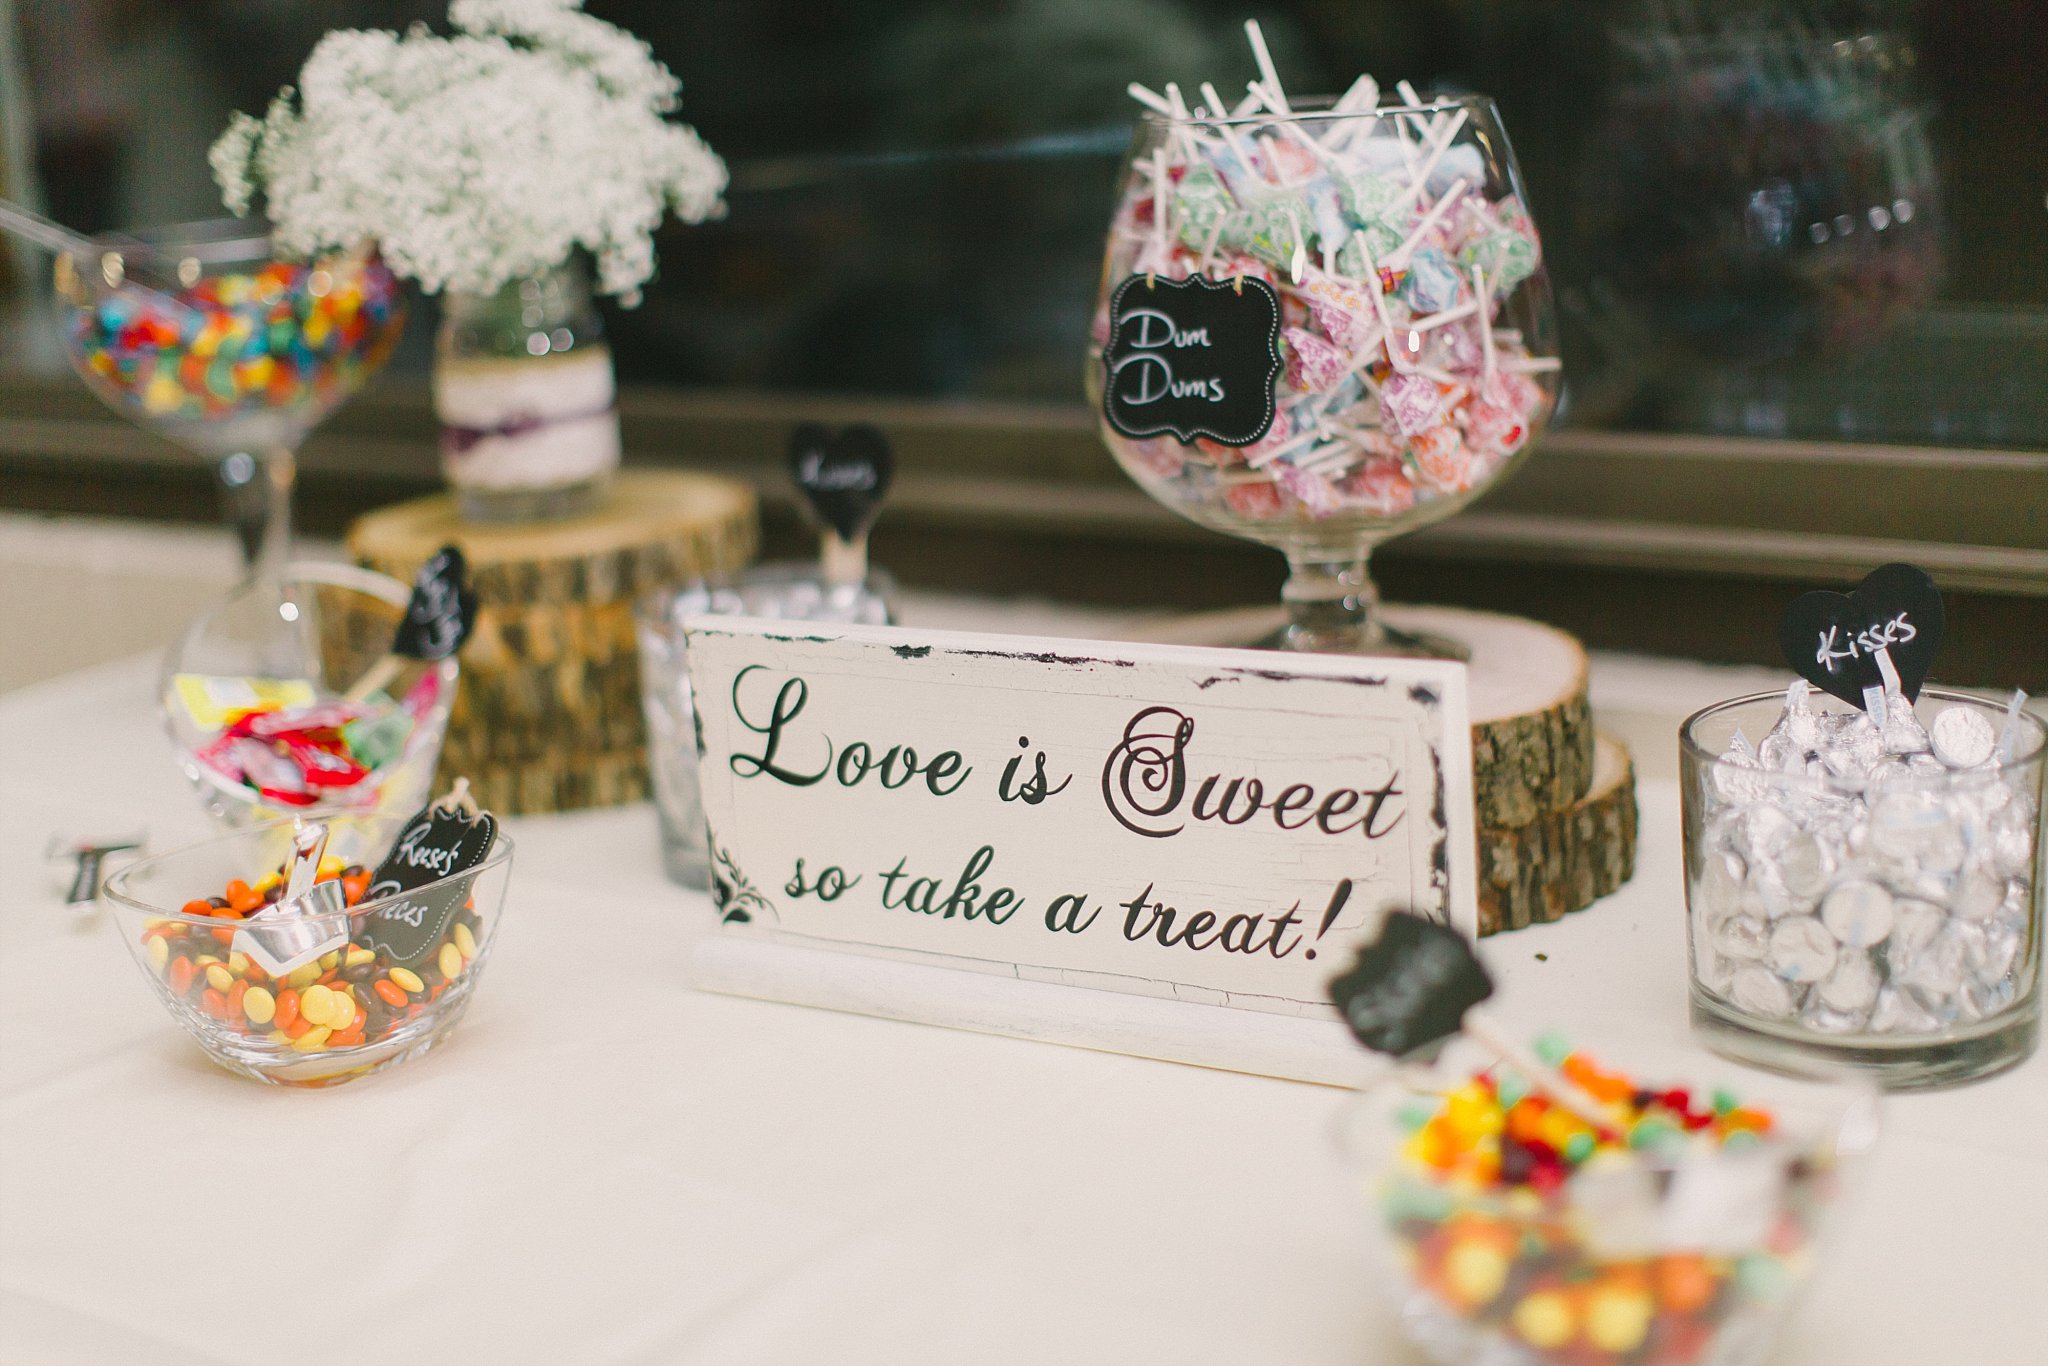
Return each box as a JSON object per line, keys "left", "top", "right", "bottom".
{"left": 1102, "top": 274, "right": 1282, "bottom": 446}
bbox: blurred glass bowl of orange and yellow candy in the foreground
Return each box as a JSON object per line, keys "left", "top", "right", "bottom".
{"left": 1339, "top": 1036, "right": 1878, "bottom": 1366}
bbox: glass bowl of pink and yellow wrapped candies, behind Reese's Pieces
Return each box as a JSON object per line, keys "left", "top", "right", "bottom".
{"left": 160, "top": 563, "right": 459, "bottom": 825}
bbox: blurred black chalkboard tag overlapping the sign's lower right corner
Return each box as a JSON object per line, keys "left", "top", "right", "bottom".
{"left": 1329, "top": 911, "right": 1493, "bottom": 1057}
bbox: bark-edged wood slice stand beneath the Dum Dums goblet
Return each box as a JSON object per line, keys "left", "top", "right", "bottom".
{"left": 1135, "top": 606, "right": 1636, "bottom": 934}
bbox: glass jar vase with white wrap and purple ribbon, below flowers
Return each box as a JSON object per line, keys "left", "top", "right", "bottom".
{"left": 434, "top": 260, "right": 618, "bottom": 522}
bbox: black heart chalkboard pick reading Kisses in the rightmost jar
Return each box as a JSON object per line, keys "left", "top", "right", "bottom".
{"left": 1778, "top": 563, "right": 1948, "bottom": 707}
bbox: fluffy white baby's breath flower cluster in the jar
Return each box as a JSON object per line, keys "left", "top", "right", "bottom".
{"left": 209, "top": 0, "right": 725, "bottom": 303}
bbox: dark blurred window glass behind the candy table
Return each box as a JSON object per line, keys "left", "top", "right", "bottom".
{"left": 0, "top": 0, "right": 2048, "bottom": 449}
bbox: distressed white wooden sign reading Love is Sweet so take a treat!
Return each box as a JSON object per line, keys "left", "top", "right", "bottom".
{"left": 688, "top": 616, "right": 1477, "bottom": 1081}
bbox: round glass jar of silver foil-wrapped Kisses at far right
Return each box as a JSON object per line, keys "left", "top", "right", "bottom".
{"left": 1679, "top": 682, "right": 2048, "bottom": 1090}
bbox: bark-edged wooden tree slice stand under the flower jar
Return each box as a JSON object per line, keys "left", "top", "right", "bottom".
{"left": 348, "top": 469, "right": 760, "bottom": 815}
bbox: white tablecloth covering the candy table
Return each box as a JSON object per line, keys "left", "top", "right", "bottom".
{"left": 0, "top": 641, "right": 2048, "bottom": 1366}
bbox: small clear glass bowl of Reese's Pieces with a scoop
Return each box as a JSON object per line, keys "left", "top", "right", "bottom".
{"left": 100, "top": 813, "right": 512, "bottom": 1087}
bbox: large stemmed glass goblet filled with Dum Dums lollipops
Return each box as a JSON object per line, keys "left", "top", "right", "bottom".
{"left": 1087, "top": 47, "right": 1559, "bottom": 655}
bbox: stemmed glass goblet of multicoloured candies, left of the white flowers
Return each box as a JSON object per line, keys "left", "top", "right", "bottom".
{"left": 57, "top": 221, "right": 406, "bottom": 582}
